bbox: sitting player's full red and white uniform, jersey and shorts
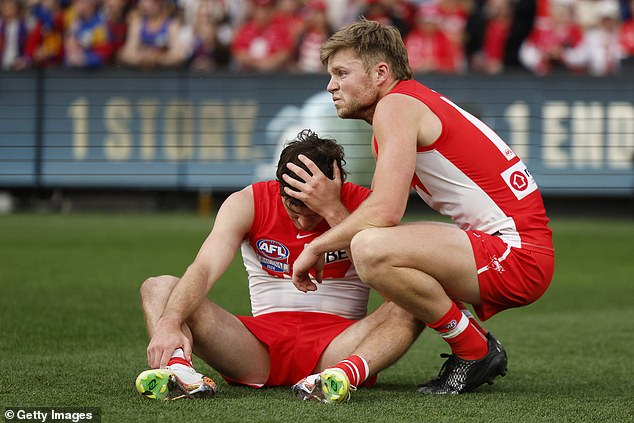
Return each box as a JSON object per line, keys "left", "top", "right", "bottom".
{"left": 234, "top": 181, "right": 370, "bottom": 386}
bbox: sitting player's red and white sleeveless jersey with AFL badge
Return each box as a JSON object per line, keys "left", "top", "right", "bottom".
{"left": 241, "top": 181, "right": 370, "bottom": 319}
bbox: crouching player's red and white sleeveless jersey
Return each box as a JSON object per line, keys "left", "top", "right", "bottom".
{"left": 374, "top": 80, "right": 552, "bottom": 252}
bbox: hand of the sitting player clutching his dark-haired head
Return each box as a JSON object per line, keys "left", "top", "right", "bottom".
{"left": 282, "top": 154, "right": 342, "bottom": 216}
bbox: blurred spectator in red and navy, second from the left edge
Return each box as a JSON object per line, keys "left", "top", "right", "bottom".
{"left": 24, "top": 0, "right": 64, "bottom": 67}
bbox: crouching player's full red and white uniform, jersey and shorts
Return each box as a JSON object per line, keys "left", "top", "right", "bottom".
{"left": 374, "top": 80, "right": 554, "bottom": 320}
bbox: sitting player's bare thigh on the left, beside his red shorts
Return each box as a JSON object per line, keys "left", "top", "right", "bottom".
{"left": 187, "top": 299, "right": 270, "bottom": 383}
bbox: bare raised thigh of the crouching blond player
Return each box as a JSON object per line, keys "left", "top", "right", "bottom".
{"left": 352, "top": 222, "right": 480, "bottom": 303}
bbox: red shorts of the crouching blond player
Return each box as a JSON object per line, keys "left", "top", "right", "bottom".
{"left": 466, "top": 231, "right": 555, "bottom": 321}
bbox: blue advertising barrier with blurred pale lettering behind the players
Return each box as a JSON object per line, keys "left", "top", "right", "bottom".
{"left": 0, "top": 70, "right": 634, "bottom": 197}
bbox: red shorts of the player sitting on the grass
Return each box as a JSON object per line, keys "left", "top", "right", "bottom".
{"left": 225, "top": 311, "right": 357, "bottom": 387}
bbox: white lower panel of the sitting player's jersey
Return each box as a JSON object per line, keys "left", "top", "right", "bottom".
{"left": 241, "top": 240, "right": 370, "bottom": 319}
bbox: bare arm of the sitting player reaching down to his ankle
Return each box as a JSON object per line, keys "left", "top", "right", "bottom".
{"left": 147, "top": 186, "right": 253, "bottom": 368}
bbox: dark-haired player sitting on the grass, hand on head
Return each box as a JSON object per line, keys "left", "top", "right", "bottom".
{"left": 136, "top": 130, "right": 424, "bottom": 402}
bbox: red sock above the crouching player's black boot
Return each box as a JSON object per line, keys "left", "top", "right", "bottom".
{"left": 427, "top": 302, "right": 489, "bottom": 360}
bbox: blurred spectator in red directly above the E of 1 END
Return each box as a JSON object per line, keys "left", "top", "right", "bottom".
{"left": 519, "top": 0, "right": 583, "bottom": 75}
